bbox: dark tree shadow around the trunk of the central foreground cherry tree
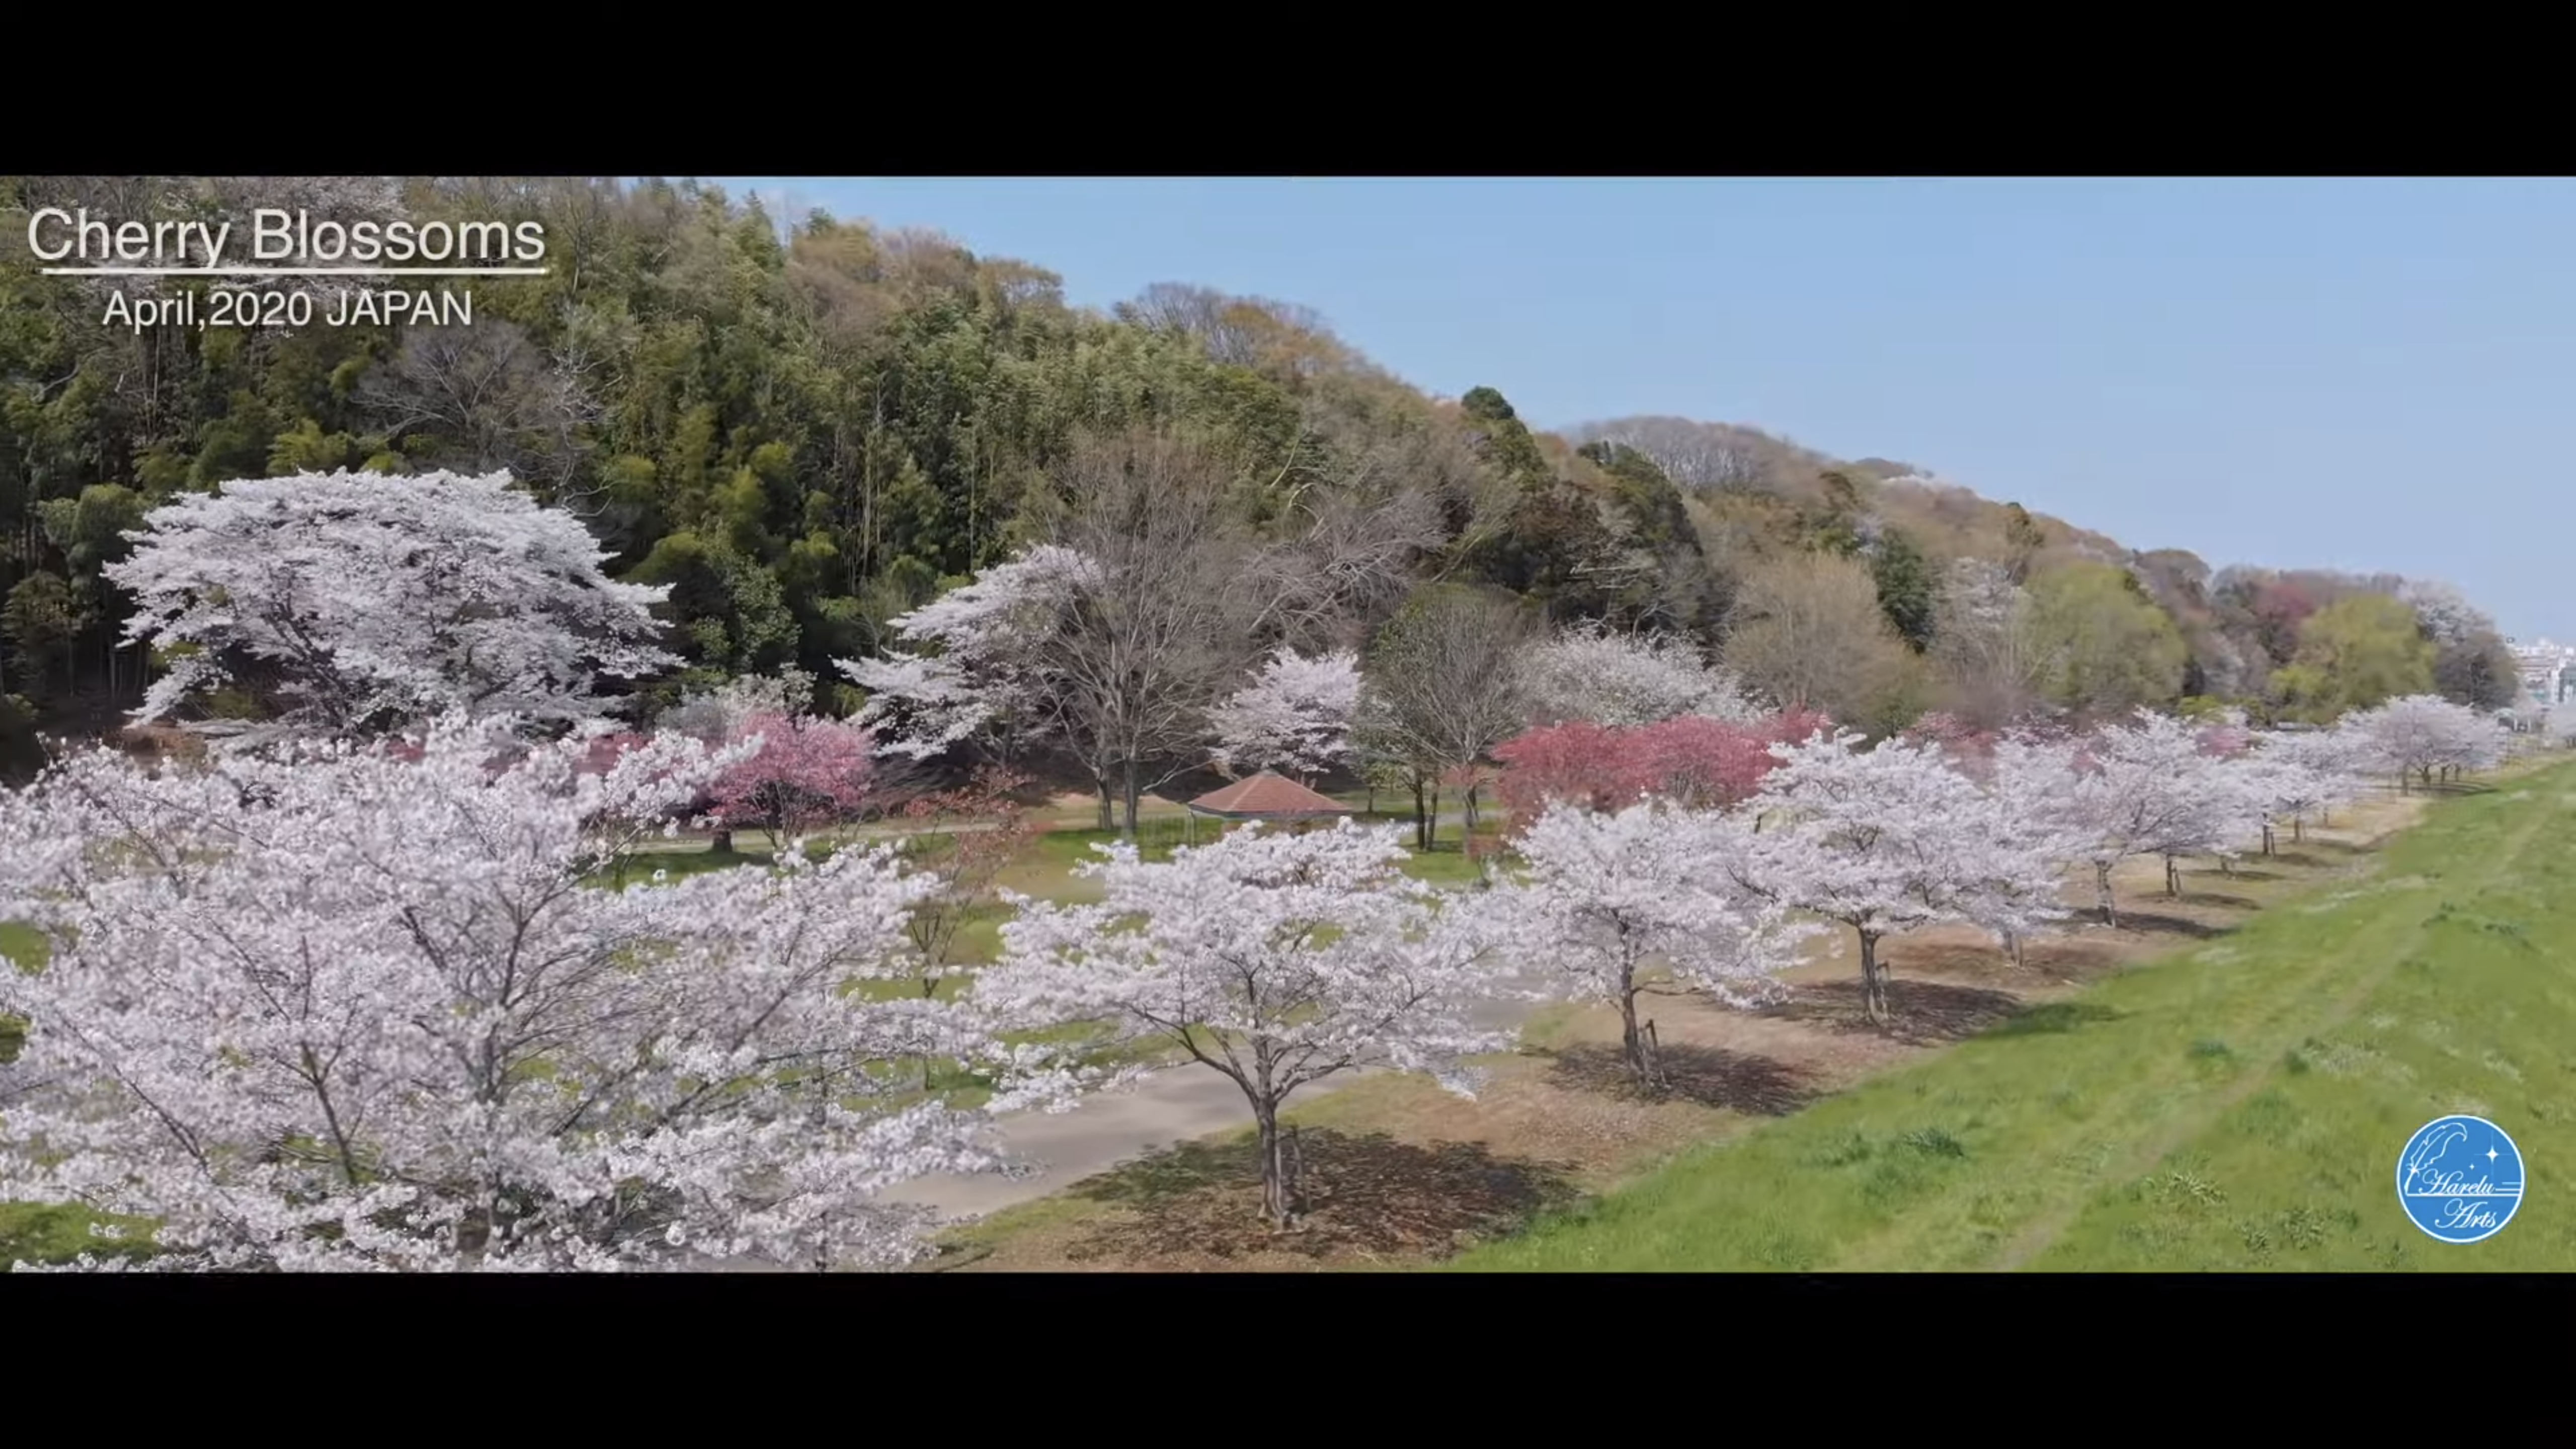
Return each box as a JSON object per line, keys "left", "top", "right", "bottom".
{"left": 1064, "top": 1130, "right": 1576, "bottom": 1263}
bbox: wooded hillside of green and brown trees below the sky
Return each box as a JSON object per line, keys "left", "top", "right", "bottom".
{"left": 0, "top": 178, "right": 2514, "bottom": 789}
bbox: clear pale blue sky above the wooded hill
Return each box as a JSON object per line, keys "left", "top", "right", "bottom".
{"left": 711, "top": 178, "right": 2576, "bottom": 639}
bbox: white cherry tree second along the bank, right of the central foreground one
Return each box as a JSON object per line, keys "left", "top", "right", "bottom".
{"left": 1486, "top": 802, "right": 1813, "bottom": 1088}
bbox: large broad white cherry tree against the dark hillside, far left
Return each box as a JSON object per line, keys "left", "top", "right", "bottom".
{"left": 106, "top": 472, "right": 678, "bottom": 743}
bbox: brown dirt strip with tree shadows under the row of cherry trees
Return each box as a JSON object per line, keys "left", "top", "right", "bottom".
{"left": 925, "top": 796, "right": 2424, "bottom": 1271}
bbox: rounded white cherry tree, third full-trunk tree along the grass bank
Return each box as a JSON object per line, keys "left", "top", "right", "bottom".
{"left": 1746, "top": 730, "right": 2038, "bottom": 1026}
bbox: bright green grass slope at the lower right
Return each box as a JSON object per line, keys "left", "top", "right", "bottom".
{"left": 1451, "top": 766, "right": 2576, "bottom": 1271}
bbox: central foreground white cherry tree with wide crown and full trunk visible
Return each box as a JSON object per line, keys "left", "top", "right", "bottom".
{"left": 971, "top": 820, "right": 1512, "bottom": 1227}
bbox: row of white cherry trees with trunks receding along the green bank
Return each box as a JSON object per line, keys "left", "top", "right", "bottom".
{"left": 974, "top": 699, "right": 2502, "bottom": 1222}
